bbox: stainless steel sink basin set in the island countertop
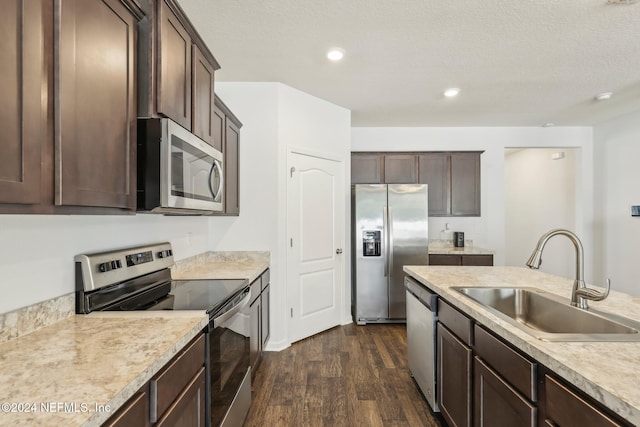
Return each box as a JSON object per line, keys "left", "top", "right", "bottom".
{"left": 452, "top": 287, "right": 640, "bottom": 341}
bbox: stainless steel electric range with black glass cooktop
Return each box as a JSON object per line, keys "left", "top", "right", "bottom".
{"left": 75, "top": 243, "right": 251, "bottom": 427}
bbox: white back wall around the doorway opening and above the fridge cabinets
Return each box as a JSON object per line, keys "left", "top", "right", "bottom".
{"left": 351, "top": 127, "right": 593, "bottom": 280}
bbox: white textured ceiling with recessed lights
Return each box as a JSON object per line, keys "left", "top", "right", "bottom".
{"left": 180, "top": 0, "right": 640, "bottom": 126}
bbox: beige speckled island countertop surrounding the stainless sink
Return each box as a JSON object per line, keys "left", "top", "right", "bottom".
{"left": 404, "top": 266, "right": 640, "bottom": 425}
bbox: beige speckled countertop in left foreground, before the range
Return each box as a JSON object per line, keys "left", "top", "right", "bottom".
{"left": 0, "top": 311, "right": 208, "bottom": 427}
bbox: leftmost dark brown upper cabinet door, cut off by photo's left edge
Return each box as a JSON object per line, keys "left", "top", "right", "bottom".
{"left": 0, "top": 0, "right": 48, "bottom": 204}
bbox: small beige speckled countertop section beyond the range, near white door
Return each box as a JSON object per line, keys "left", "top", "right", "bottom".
{"left": 171, "top": 251, "right": 271, "bottom": 282}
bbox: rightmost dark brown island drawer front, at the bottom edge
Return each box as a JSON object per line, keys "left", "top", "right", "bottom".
{"left": 544, "top": 375, "right": 624, "bottom": 427}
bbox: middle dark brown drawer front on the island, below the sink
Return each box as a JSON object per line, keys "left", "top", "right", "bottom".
{"left": 473, "top": 325, "right": 538, "bottom": 402}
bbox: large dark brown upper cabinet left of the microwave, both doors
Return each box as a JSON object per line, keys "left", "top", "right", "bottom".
{"left": 0, "top": 0, "right": 144, "bottom": 214}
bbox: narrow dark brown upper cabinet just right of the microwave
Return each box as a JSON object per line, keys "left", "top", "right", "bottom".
{"left": 213, "top": 97, "right": 242, "bottom": 216}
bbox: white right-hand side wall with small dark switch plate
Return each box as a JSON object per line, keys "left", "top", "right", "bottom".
{"left": 594, "top": 111, "right": 640, "bottom": 295}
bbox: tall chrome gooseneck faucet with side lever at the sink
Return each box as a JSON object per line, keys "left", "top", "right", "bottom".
{"left": 527, "top": 228, "right": 611, "bottom": 310}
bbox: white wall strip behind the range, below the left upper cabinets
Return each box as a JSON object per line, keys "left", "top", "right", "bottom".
{"left": 0, "top": 214, "right": 209, "bottom": 313}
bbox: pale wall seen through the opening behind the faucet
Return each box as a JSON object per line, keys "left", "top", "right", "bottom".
{"left": 505, "top": 148, "right": 581, "bottom": 278}
